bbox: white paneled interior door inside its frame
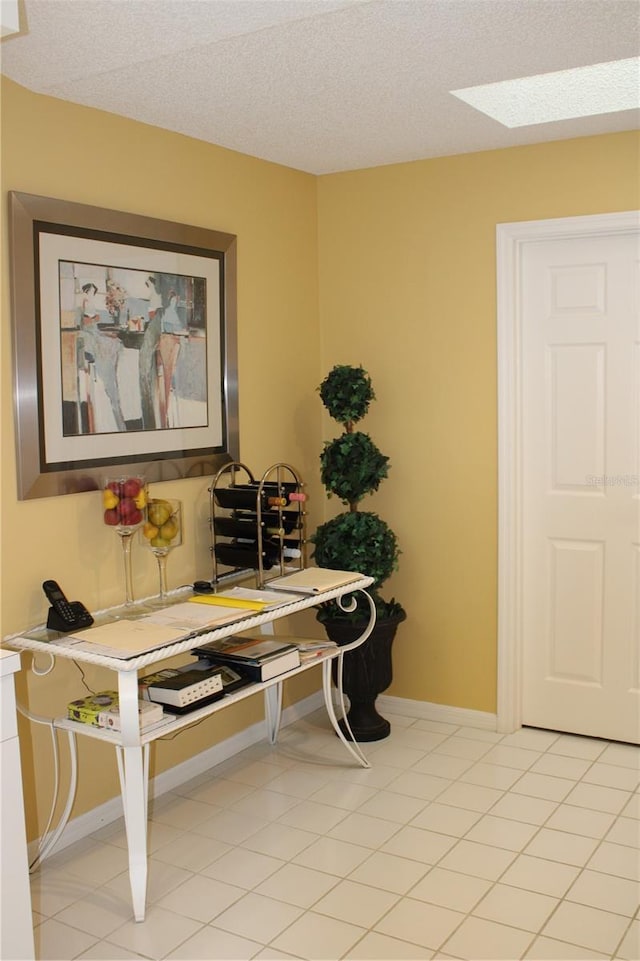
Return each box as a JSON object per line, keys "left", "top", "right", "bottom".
{"left": 519, "top": 230, "right": 640, "bottom": 743}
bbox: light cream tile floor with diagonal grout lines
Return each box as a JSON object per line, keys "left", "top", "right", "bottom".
{"left": 32, "top": 712, "right": 640, "bottom": 961}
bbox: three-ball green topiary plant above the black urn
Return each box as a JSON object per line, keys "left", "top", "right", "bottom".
{"left": 310, "top": 364, "right": 404, "bottom": 621}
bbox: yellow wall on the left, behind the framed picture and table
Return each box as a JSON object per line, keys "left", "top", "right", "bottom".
{"left": 0, "top": 79, "right": 322, "bottom": 837}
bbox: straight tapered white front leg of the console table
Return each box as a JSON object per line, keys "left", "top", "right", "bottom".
{"left": 117, "top": 671, "right": 149, "bottom": 921}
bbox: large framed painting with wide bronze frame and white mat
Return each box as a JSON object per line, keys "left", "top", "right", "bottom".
{"left": 9, "top": 192, "right": 239, "bottom": 500}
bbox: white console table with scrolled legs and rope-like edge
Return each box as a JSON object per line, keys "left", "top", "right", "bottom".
{"left": 4, "top": 577, "right": 376, "bottom": 921}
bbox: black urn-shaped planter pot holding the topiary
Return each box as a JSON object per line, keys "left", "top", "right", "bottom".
{"left": 323, "top": 611, "right": 406, "bottom": 741}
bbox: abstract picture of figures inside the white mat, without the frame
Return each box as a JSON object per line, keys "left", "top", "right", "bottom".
{"left": 58, "top": 260, "right": 208, "bottom": 437}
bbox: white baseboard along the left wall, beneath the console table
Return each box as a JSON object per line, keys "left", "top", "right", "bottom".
{"left": 29, "top": 691, "right": 324, "bottom": 862}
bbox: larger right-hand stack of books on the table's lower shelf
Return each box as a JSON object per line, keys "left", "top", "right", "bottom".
{"left": 193, "top": 637, "right": 300, "bottom": 682}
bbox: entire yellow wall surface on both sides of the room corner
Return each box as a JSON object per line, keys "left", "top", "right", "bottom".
{"left": 0, "top": 80, "right": 640, "bottom": 836}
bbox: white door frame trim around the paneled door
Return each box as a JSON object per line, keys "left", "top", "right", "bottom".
{"left": 496, "top": 210, "right": 640, "bottom": 733}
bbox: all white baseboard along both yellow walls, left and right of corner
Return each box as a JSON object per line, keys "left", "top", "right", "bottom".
{"left": 29, "top": 691, "right": 497, "bottom": 861}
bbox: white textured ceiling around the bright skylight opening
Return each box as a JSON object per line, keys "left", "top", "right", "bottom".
{"left": 0, "top": 0, "right": 640, "bottom": 174}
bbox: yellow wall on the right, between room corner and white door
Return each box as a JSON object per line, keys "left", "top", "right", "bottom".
{"left": 318, "top": 133, "right": 640, "bottom": 712}
